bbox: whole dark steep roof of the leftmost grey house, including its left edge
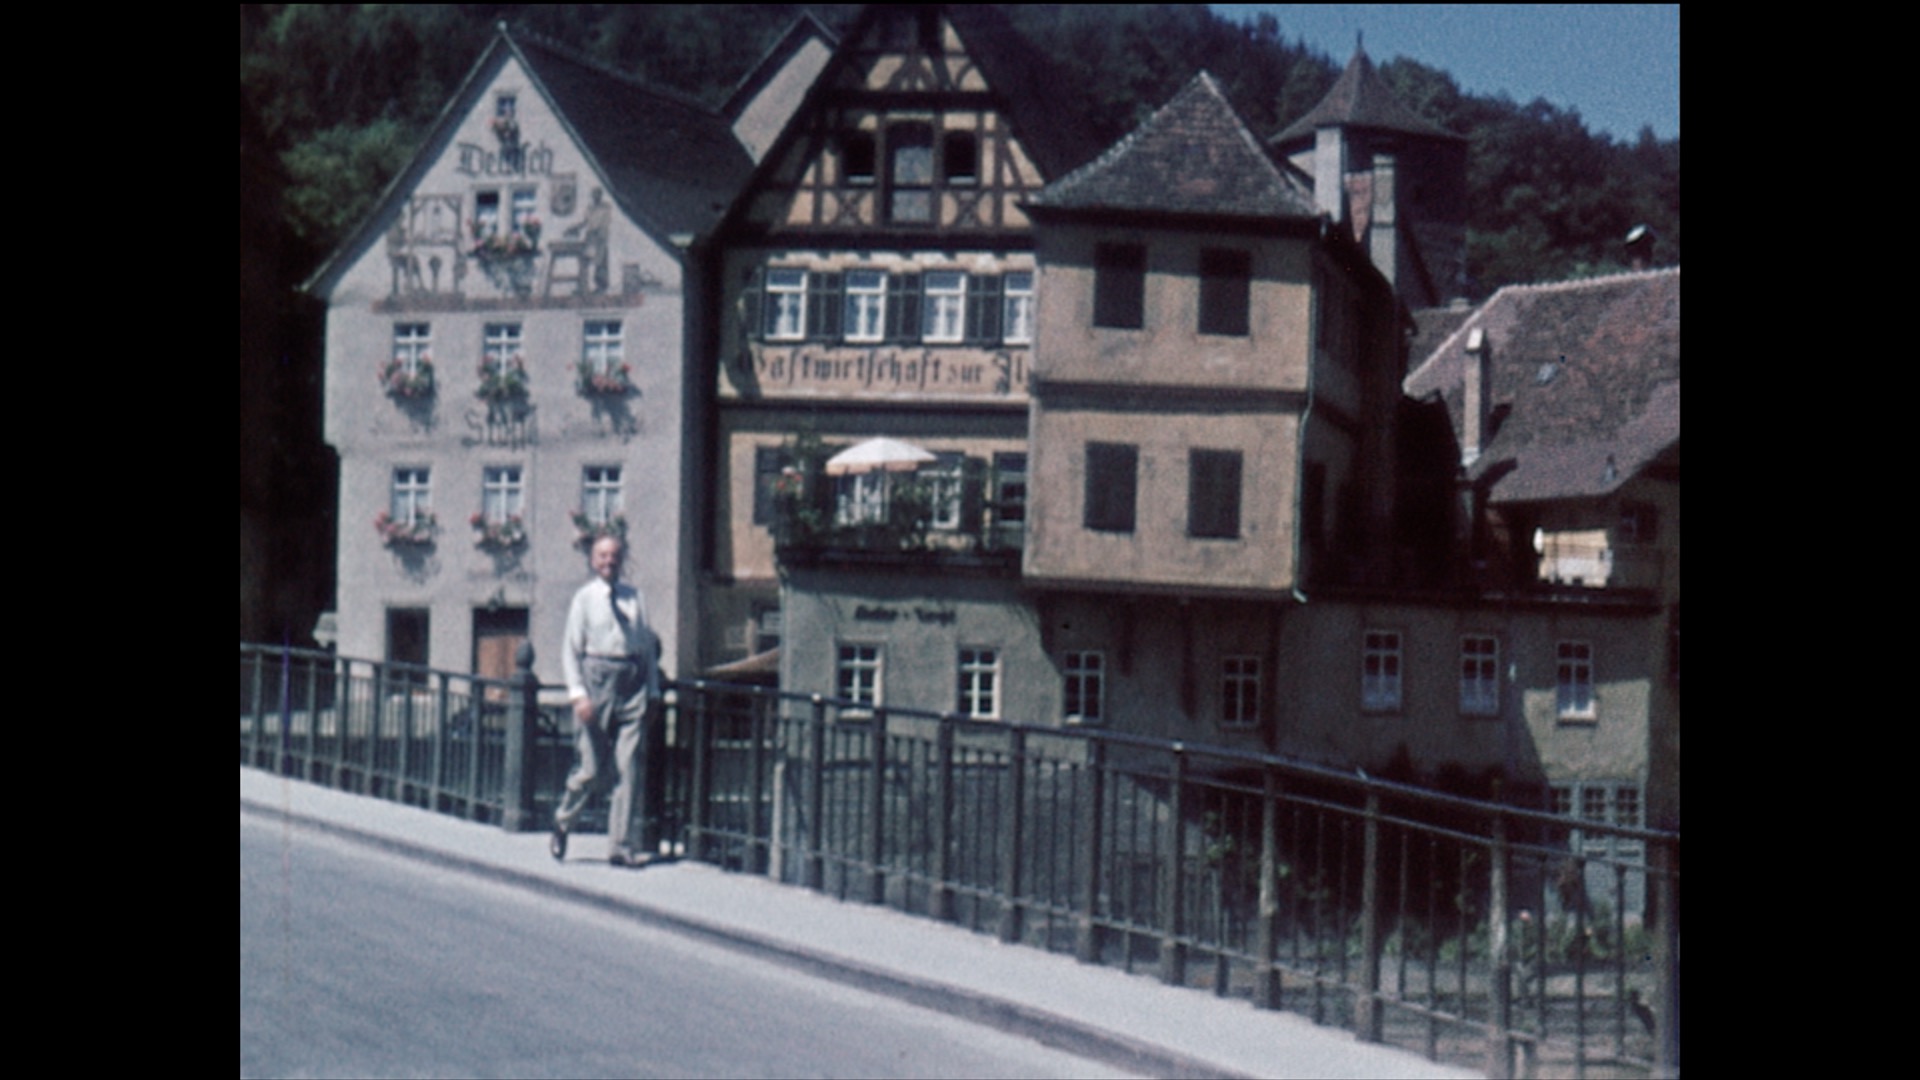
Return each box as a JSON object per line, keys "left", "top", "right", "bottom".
{"left": 301, "top": 25, "right": 753, "bottom": 294}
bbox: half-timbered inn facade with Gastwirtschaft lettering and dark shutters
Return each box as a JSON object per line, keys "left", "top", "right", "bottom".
{"left": 703, "top": 6, "right": 1077, "bottom": 663}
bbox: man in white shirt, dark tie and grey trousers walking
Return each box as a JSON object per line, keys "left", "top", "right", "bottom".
{"left": 549, "top": 536, "right": 660, "bottom": 867}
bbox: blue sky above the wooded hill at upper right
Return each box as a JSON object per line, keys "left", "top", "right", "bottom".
{"left": 1212, "top": 4, "right": 1680, "bottom": 142}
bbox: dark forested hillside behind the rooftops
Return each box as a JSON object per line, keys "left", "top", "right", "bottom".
{"left": 240, "top": 4, "right": 1680, "bottom": 298}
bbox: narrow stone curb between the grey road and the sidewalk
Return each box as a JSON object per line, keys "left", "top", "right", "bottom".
{"left": 240, "top": 798, "right": 1252, "bottom": 1080}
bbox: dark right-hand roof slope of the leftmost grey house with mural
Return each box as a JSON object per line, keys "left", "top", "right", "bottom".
{"left": 511, "top": 35, "right": 753, "bottom": 234}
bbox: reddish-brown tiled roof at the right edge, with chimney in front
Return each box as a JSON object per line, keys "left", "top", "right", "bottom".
{"left": 1404, "top": 267, "right": 1680, "bottom": 503}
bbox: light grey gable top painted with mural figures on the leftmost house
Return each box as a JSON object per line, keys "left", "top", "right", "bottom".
{"left": 374, "top": 67, "right": 660, "bottom": 311}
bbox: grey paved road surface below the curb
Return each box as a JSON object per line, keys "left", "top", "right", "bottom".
{"left": 240, "top": 811, "right": 1127, "bottom": 1076}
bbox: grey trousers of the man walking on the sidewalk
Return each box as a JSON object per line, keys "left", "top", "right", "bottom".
{"left": 553, "top": 657, "right": 653, "bottom": 851}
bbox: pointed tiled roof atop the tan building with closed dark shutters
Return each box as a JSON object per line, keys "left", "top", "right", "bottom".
{"left": 1031, "top": 71, "right": 1319, "bottom": 219}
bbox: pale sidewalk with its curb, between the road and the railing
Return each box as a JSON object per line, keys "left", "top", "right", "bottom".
{"left": 240, "top": 769, "right": 1478, "bottom": 1078}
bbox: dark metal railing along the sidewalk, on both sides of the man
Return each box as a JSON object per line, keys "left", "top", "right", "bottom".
{"left": 242, "top": 646, "right": 1680, "bottom": 1076}
